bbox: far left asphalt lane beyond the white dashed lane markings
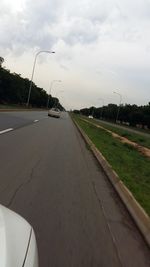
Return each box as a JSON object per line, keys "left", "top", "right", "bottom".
{"left": 0, "top": 111, "right": 47, "bottom": 133}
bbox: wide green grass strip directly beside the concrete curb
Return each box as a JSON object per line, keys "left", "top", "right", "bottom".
{"left": 74, "top": 116, "right": 150, "bottom": 215}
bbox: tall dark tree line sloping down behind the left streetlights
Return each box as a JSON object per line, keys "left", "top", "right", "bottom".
{"left": 0, "top": 57, "right": 63, "bottom": 109}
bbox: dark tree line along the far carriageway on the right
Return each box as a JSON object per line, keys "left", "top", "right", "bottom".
{"left": 74, "top": 102, "right": 150, "bottom": 129}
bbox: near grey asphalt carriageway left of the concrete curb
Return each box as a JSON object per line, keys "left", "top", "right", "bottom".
{"left": 0, "top": 112, "right": 150, "bottom": 267}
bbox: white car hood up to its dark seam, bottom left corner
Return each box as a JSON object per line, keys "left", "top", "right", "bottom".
{"left": 0, "top": 205, "right": 31, "bottom": 267}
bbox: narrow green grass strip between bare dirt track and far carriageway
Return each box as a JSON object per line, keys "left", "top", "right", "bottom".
{"left": 84, "top": 118, "right": 150, "bottom": 151}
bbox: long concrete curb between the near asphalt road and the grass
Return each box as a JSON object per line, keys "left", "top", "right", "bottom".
{"left": 73, "top": 120, "right": 150, "bottom": 247}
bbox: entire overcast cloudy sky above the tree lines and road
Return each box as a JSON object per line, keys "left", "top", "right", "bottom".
{"left": 0, "top": 0, "right": 150, "bottom": 109}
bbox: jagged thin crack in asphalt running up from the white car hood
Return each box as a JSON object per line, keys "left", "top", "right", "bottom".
{"left": 6, "top": 159, "right": 41, "bottom": 208}
